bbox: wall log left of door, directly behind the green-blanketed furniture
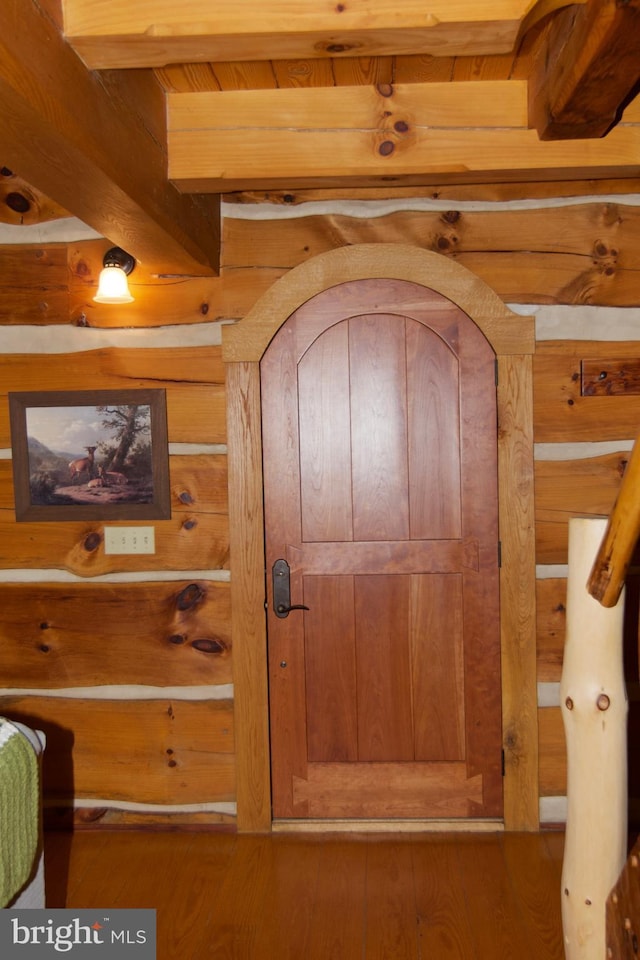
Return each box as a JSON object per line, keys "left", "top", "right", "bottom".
{"left": 0, "top": 696, "right": 235, "bottom": 807}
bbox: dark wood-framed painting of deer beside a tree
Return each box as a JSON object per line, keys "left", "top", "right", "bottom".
{"left": 9, "top": 389, "right": 171, "bottom": 521}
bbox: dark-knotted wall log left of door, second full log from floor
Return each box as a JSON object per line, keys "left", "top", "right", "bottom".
{"left": 0, "top": 580, "right": 232, "bottom": 690}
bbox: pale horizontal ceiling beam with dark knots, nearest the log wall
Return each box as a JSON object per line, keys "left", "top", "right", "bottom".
{"left": 167, "top": 80, "right": 640, "bottom": 193}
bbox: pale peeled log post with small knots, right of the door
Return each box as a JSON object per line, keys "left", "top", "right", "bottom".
{"left": 560, "top": 519, "right": 627, "bottom": 960}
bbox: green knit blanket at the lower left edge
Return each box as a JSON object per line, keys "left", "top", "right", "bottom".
{"left": 0, "top": 718, "right": 40, "bottom": 907}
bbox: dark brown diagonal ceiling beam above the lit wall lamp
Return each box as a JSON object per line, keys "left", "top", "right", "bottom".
{"left": 0, "top": 0, "right": 220, "bottom": 276}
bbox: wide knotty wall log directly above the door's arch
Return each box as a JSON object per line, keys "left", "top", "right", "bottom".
{"left": 224, "top": 206, "right": 640, "bottom": 316}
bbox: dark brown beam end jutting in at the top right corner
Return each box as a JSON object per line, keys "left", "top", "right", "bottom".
{"left": 529, "top": 0, "right": 640, "bottom": 140}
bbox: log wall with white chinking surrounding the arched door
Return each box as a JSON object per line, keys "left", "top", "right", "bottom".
{"left": 0, "top": 184, "right": 640, "bottom": 826}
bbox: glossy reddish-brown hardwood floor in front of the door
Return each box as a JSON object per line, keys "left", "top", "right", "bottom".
{"left": 45, "top": 830, "right": 564, "bottom": 960}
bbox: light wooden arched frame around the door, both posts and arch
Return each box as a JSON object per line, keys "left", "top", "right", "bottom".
{"left": 222, "top": 244, "right": 539, "bottom": 832}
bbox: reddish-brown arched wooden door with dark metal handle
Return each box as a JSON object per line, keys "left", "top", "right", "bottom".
{"left": 260, "top": 279, "right": 502, "bottom": 819}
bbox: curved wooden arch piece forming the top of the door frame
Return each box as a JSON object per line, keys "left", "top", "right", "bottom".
{"left": 222, "top": 243, "right": 535, "bottom": 363}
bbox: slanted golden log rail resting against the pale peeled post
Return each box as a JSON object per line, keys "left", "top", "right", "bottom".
{"left": 588, "top": 437, "right": 640, "bottom": 607}
